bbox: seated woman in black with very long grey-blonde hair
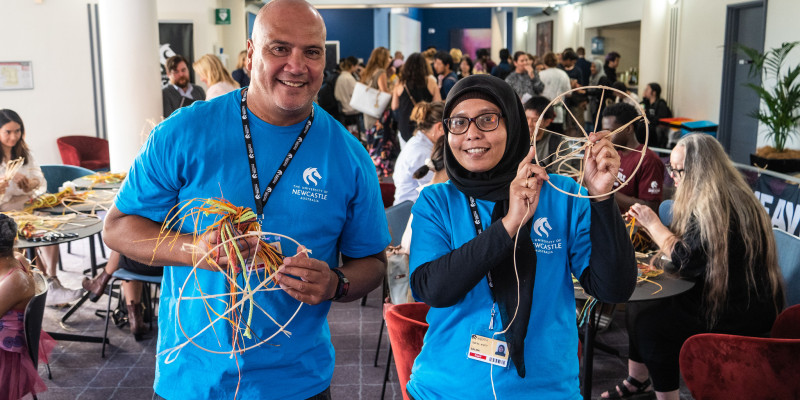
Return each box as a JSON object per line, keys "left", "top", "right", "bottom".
{"left": 603, "top": 134, "right": 784, "bottom": 400}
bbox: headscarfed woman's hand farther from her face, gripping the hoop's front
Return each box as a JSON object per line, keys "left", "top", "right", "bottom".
{"left": 583, "top": 131, "right": 620, "bottom": 200}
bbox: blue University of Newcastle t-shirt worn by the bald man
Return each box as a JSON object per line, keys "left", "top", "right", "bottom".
{"left": 116, "top": 90, "right": 390, "bottom": 399}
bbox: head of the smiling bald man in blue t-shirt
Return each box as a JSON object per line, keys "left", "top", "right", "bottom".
{"left": 247, "top": 0, "right": 325, "bottom": 125}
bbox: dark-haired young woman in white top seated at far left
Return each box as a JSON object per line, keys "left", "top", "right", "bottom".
{"left": 0, "top": 109, "right": 82, "bottom": 305}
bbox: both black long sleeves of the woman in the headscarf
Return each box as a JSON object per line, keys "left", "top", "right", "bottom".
{"left": 410, "top": 196, "right": 636, "bottom": 307}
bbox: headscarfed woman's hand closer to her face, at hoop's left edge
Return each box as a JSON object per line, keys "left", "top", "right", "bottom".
{"left": 502, "top": 146, "right": 550, "bottom": 237}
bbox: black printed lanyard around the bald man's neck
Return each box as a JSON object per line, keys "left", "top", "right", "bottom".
{"left": 242, "top": 88, "right": 314, "bottom": 218}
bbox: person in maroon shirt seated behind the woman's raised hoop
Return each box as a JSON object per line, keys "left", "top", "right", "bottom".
{"left": 603, "top": 103, "right": 664, "bottom": 216}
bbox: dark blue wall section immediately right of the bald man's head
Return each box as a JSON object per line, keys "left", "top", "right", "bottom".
{"left": 319, "top": 9, "right": 375, "bottom": 62}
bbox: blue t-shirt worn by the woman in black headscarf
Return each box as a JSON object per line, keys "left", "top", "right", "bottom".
{"left": 406, "top": 175, "right": 591, "bottom": 400}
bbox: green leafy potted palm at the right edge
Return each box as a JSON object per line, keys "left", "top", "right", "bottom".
{"left": 739, "top": 41, "right": 800, "bottom": 172}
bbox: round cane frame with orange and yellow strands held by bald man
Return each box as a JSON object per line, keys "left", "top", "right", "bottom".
{"left": 154, "top": 198, "right": 310, "bottom": 397}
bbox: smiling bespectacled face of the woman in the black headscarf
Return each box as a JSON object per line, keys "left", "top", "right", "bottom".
{"left": 447, "top": 99, "right": 507, "bottom": 172}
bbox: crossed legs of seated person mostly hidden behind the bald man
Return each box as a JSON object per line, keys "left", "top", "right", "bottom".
{"left": 81, "top": 251, "right": 164, "bottom": 341}
